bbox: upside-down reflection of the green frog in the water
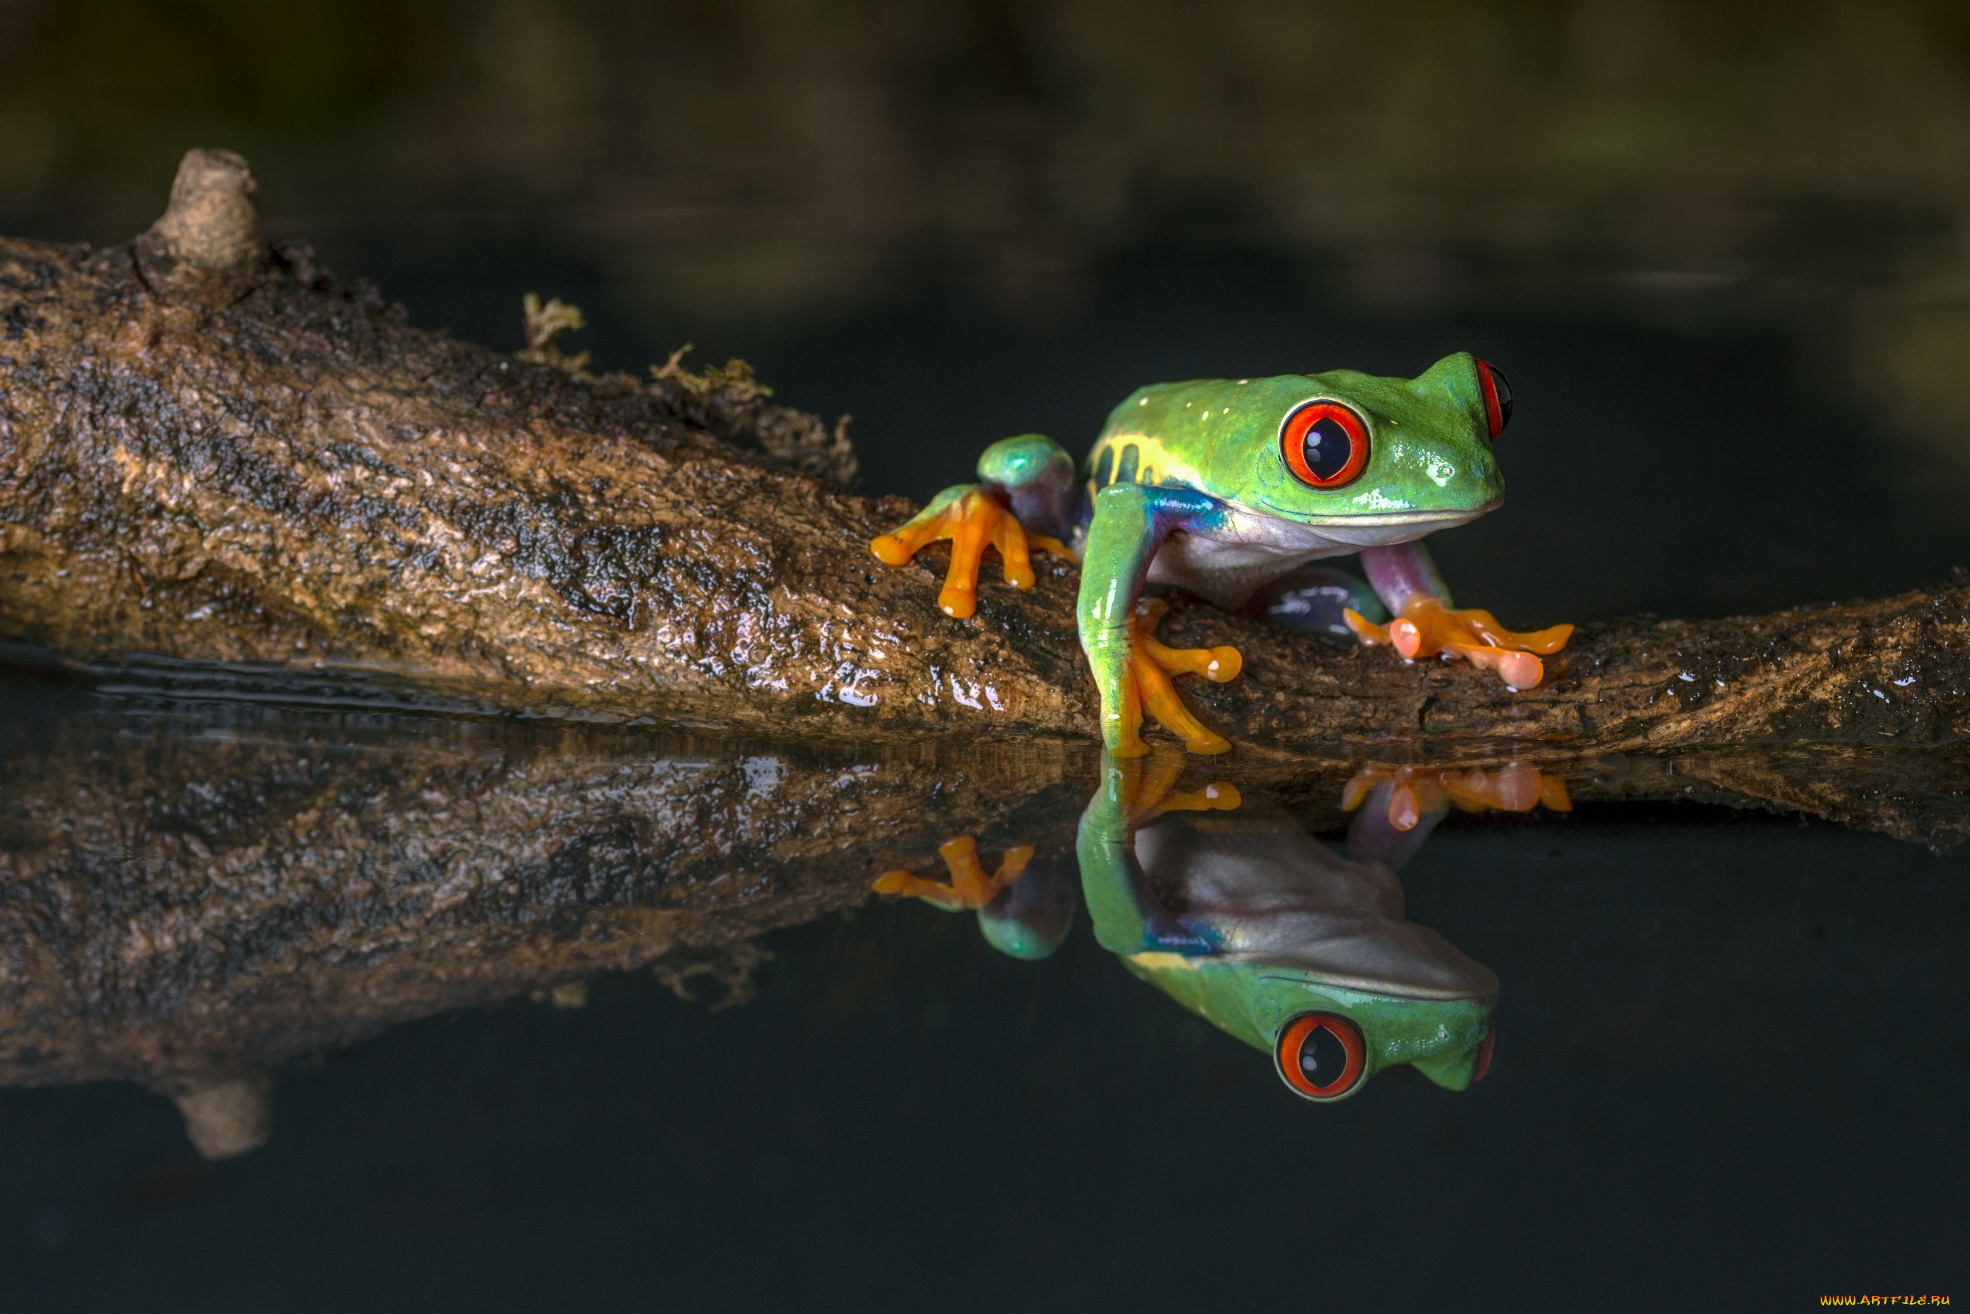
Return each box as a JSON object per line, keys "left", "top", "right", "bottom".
{"left": 1076, "top": 755, "right": 1499, "bottom": 1103}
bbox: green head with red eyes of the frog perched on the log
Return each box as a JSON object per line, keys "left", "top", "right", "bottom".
{"left": 1217, "top": 351, "right": 1511, "bottom": 538}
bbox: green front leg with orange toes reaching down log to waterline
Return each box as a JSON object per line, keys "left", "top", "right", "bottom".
{"left": 1078, "top": 485, "right": 1241, "bottom": 756}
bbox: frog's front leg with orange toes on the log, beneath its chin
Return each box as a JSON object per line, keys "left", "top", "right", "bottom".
{"left": 1346, "top": 538, "right": 1574, "bottom": 690}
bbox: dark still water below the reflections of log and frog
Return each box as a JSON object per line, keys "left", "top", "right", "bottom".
{"left": 0, "top": 818, "right": 1970, "bottom": 1308}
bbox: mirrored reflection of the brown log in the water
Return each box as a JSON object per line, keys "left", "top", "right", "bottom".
{"left": 0, "top": 685, "right": 1970, "bottom": 1154}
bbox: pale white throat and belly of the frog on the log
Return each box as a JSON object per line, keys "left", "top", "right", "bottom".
{"left": 1149, "top": 506, "right": 1489, "bottom": 607}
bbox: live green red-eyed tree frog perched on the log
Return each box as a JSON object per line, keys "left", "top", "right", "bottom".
{"left": 869, "top": 351, "right": 1574, "bottom": 758}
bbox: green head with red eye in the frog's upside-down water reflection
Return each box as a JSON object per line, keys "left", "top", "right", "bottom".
{"left": 1129, "top": 957, "right": 1497, "bottom": 1101}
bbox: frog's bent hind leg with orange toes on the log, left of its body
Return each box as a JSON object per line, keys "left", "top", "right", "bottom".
{"left": 869, "top": 433, "right": 1074, "bottom": 621}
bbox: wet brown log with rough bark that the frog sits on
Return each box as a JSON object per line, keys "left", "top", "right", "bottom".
{"left": 0, "top": 152, "right": 1970, "bottom": 762}
